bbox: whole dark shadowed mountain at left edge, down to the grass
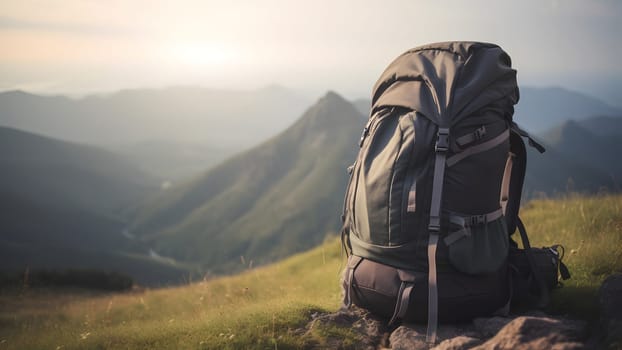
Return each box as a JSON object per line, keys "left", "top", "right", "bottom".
{"left": 0, "top": 127, "right": 193, "bottom": 281}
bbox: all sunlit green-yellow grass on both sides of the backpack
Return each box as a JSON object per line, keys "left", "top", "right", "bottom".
{"left": 0, "top": 195, "right": 622, "bottom": 349}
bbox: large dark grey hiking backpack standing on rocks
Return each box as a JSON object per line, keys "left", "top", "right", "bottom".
{"left": 342, "top": 42, "right": 572, "bottom": 342}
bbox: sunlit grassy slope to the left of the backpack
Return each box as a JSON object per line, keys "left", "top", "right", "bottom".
{"left": 0, "top": 234, "right": 341, "bottom": 349}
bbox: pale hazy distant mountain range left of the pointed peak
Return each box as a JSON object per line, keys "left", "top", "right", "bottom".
{"left": 0, "top": 86, "right": 310, "bottom": 180}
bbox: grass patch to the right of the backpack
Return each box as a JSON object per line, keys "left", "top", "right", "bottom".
{"left": 517, "top": 195, "right": 622, "bottom": 320}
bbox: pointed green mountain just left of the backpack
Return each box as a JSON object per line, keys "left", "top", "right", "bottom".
{"left": 131, "top": 92, "right": 364, "bottom": 272}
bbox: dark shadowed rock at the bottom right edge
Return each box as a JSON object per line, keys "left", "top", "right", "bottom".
{"left": 598, "top": 273, "right": 622, "bottom": 349}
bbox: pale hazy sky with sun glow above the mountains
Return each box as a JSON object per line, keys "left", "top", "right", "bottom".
{"left": 0, "top": 0, "right": 622, "bottom": 106}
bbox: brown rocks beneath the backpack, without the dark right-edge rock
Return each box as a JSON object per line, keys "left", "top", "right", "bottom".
{"left": 294, "top": 299, "right": 596, "bottom": 350}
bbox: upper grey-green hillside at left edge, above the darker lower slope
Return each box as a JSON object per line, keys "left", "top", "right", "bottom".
{"left": 0, "top": 127, "right": 158, "bottom": 213}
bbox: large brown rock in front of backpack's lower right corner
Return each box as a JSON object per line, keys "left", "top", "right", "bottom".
{"left": 475, "top": 316, "right": 586, "bottom": 350}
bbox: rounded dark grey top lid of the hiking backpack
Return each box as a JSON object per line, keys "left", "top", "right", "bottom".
{"left": 372, "top": 42, "right": 519, "bottom": 127}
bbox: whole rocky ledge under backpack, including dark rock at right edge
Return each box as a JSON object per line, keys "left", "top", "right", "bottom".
{"left": 299, "top": 274, "right": 622, "bottom": 350}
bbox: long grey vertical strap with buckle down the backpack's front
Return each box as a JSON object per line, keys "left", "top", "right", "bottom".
{"left": 426, "top": 128, "right": 449, "bottom": 343}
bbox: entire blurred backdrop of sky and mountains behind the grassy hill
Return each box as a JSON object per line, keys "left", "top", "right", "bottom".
{"left": 0, "top": 0, "right": 622, "bottom": 286}
